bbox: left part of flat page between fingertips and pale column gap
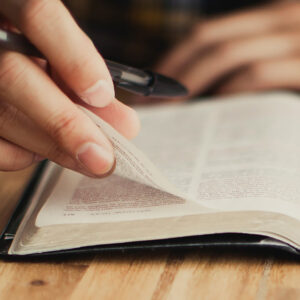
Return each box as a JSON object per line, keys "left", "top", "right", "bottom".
{"left": 134, "top": 102, "right": 213, "bottom": 197}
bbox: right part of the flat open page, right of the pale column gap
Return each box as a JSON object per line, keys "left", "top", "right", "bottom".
{"left": 196, "top": 94, "right": 300, "bottom": 218}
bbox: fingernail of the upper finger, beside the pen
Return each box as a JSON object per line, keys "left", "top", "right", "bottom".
{"left": 79, "top": 80, "right": 115, "bottom": 107}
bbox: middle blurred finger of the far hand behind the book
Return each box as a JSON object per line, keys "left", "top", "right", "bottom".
{"left": 178, "top": 31, "right": 300, "bottom": 96}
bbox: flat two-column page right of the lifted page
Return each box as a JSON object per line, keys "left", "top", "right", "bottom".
{"left": 136, "top": 92, "right": 300, "bottom": 218}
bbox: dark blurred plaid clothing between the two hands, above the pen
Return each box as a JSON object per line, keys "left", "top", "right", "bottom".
{"left": 64, "top": 0, "right": 268, "bottom": 68}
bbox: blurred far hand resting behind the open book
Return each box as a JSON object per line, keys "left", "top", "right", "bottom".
{"left": 157, "top": 1, "right": 300, "bottom": 97}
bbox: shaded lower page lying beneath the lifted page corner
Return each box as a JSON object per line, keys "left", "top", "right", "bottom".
{"left": 36, "top": 170, "right": 204, "bottom": 227}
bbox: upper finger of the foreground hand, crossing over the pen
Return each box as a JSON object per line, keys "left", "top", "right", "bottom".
{"left": 0, "top": 0, "right": 114, "bottom": 107}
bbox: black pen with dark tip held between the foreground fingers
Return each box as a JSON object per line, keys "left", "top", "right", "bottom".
{"left": 0, "top": 29, "right": 188, "bottom": 97}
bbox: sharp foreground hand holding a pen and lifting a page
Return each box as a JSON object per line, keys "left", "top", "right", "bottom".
{"left": 0, "top": 0, "right": 139, "bottom": 176}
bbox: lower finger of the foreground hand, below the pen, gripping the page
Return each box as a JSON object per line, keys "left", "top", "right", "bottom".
{"left": 0, "top": 52, "right": 114, "bottom": 175}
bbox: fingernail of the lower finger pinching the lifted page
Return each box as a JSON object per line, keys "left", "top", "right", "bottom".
{"left": 77, "top": 143, "right": 115, "bottom": 175}
